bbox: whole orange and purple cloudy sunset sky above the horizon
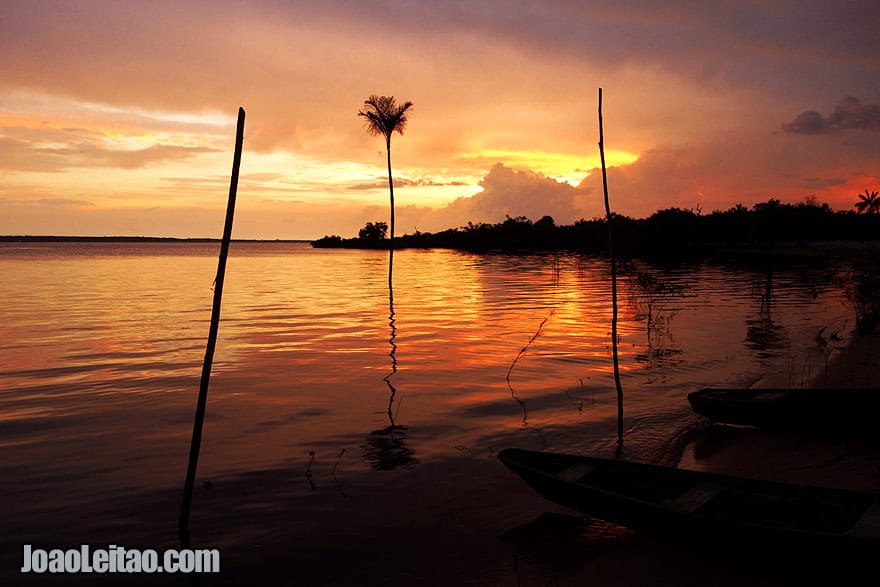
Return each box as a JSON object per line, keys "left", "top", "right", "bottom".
{"left": 0, "top": 0, "right": 880, "bottom": 239}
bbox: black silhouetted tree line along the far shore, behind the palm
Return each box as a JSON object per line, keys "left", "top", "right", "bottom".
{"left": 312, "top": 198, "right": 880, "bottom": 255}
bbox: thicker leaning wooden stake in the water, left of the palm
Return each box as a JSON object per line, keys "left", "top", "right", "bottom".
{"left": 178, "top": 108, "right": 244, "bottom": 535}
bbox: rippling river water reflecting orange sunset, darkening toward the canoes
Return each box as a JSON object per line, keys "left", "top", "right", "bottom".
{"left": 0, "top": 243, "right": 868, "bottom": 585}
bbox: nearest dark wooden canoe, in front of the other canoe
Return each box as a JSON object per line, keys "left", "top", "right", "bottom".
{"left": 499, "top": 449, "right": 880, "bottom": 552}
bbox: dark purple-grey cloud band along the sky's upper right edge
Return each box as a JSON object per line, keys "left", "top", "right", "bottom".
{"left": 363, "top": 0, "right": 880, "bottom": 93}
